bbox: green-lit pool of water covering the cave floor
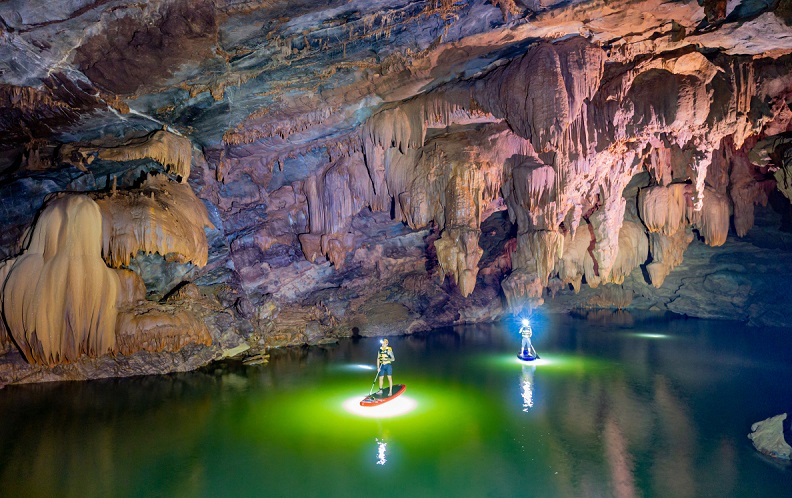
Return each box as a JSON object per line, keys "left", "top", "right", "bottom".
{"left": 0, "top": 312, "right": 792, "bottom": 497}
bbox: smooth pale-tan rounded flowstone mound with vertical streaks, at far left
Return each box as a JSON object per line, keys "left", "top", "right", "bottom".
{"left": 2, "top": 195, "right": 120, "bottom": 365}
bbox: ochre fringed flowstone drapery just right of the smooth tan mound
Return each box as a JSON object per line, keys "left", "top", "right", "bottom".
{"left": 96, "top": 175, "right": 212, "bottom": 268}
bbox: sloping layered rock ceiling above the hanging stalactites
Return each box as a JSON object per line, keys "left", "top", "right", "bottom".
{"left": 0, "top": 0, "right": 792, "bottom": 171}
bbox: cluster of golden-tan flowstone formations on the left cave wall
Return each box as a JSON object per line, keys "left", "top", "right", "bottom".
{"left": 0, "top": 128, "right": 217, "bottom": 374}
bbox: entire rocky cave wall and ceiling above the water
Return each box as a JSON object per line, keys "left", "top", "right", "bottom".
{"left": 0, "top": 0, "right": 792, "bottom": 380}
